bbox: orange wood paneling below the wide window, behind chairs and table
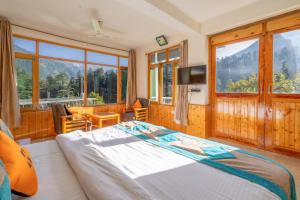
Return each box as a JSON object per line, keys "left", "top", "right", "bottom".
{"left": 12, "top": 104, "right": 125, "bottom": 140}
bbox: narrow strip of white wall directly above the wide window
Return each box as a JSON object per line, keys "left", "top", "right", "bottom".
{"left": 12, "top": 26, "right": 128, "bottom": 56}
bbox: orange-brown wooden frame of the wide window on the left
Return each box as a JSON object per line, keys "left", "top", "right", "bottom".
{"left": 13, "top": 34, "right": 128, "bottom": 110}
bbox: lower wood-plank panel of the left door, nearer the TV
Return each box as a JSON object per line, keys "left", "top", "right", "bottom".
{"left": 215, "top": 97, "right": 259, "bottom": 145}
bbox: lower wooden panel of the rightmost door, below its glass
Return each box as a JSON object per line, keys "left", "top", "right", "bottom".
{"left": 271, "top": 99, "right": 300, "bottom": 152}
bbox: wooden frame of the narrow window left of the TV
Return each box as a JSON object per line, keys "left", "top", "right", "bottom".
{"left": 147, "top": 44, "right": 180, "bottom": 106}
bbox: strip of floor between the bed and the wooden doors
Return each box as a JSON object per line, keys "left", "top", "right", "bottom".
{"left": 209, "top": 138, "right": 300, "bottom": 196}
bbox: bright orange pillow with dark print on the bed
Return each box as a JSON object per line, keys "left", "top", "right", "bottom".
{"left": 0, "top": 131, "right": 38, "bottom": 197}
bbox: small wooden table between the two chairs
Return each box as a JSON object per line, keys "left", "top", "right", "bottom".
{"left": 90, "top": 112, "right": 120, "bottom": 128}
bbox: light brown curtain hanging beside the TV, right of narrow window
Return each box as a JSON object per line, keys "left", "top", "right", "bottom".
{"left": 175, "top": 40, "right": 189, "bottom": 125}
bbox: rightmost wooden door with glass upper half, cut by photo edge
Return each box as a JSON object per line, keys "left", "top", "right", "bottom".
{"left": 265, "top": 26, "right": 300, "bottom": 152}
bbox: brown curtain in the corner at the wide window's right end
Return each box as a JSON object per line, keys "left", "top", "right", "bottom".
{"left": 126, "top": 50, "right": 136, "bottom": 110}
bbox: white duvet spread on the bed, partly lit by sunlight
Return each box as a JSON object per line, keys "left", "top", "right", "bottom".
{"left": 56, "top": 127, "right": 279, "bottom": 200}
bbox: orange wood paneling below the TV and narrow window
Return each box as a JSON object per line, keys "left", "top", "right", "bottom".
{"left": 149, "top": 104, "right": 209, "bottom": 138}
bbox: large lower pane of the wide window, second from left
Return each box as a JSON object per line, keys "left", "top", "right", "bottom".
{"left": 39, "top": 59, "right": 84, "bottom": 107}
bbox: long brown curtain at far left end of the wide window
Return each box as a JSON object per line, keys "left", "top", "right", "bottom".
{"left": 0, "top": 17, "right": 21, "bottom": 128}
